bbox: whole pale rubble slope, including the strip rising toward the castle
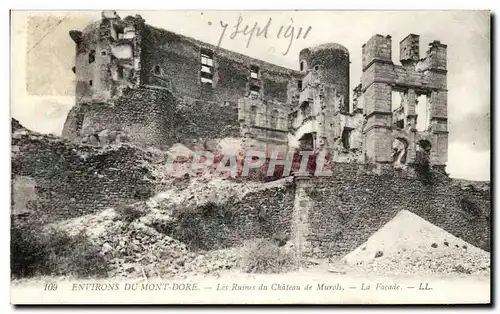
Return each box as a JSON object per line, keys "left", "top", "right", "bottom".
{"left": 48, "top": 175, "right": 274, "bottom": 278}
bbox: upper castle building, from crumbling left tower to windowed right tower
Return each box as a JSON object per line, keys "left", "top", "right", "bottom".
{"left": 63, "top": 11, "right": 448, "bottom": 168}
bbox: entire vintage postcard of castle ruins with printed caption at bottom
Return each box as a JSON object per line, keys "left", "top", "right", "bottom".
{"left": 10, "top": 10, "right": 492, "bottom": 304}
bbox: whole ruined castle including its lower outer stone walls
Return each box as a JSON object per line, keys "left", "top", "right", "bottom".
{"left": 12, "top": 12, "right": 491, "bottom": 258}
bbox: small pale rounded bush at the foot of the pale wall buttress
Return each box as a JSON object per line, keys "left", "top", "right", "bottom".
{"left": 241, "top": 239, "right": 296, "bottom": 273}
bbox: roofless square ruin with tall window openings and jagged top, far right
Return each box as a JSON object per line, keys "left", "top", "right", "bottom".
{"left": 361, "top": 34, "right": 448, "bottom": 167}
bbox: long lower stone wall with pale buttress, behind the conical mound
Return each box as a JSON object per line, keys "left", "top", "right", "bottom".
{"left": 167, "top": 163, "right": 491, "bottom": 258}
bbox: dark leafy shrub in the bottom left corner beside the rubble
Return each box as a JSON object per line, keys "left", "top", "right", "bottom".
{"left": 10, "top": 226, "right": 108, "bottom": 278}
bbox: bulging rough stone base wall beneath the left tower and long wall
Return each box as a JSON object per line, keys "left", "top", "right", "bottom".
{"left": 63, "top": 87, "right": 240, "bottom": 148}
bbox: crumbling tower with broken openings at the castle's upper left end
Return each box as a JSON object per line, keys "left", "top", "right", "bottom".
{"left": 70, "top": 11, "right": 144, "bottom": 103}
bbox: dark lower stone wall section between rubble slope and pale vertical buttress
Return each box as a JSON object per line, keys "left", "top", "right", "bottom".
{"left": 162, "top": 185, "right": 294, "bottom": 250}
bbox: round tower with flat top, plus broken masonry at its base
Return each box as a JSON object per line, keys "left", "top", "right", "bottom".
{"left": 291, "top": 43, "right": 358, "bottom": 157}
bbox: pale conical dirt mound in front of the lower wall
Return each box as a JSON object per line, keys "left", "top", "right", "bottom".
{"left": 343, "top": 210, "right": 490, "bottom": 274}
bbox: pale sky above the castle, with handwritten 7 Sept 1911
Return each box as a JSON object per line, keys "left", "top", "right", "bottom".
{"left": 11, "top": 11, "right": 491, "bottom": 180}
